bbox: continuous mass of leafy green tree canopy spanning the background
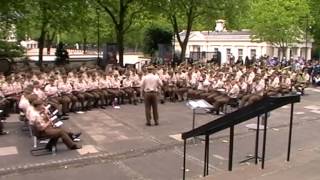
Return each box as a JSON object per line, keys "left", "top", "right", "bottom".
{"left": 0, "top": 0, "right": 320, "bottom": 65}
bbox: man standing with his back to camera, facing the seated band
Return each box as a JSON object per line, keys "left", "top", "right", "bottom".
{"left": 141, "top": 66, "right": 162, "bottom": 126}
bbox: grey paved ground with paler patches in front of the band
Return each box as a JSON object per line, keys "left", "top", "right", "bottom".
{"left": 0, "top": 89, "right": 320, "bottom": 180}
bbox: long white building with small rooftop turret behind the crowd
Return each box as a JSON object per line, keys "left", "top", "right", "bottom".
{"left": 175, "top": 20, "right": 312, "bottom": 63}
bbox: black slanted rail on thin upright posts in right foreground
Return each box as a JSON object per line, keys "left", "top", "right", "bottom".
{"left": 181, "top": 94, "right": 300, "bottom": 179}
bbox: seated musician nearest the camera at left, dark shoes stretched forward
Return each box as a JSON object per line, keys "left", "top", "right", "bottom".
{"left": 30, "top": 100, "right": 81, "bottom": 150}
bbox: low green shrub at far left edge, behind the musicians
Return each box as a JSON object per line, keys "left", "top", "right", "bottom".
{"left": 0, "top": 41, "right": 24, "bottom": 58}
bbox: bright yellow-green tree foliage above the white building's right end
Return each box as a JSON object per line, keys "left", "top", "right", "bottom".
{"left": 246, "top": 0, "right": 310, "bottom": 48}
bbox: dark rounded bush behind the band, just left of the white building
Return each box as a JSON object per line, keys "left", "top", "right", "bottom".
{"left": 143, "top": 27, "right": 173, "bottom": 55}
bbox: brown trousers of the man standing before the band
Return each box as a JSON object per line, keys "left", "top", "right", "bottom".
{"left": 144, "top": 92, "right": 159, "bottom": 124}
